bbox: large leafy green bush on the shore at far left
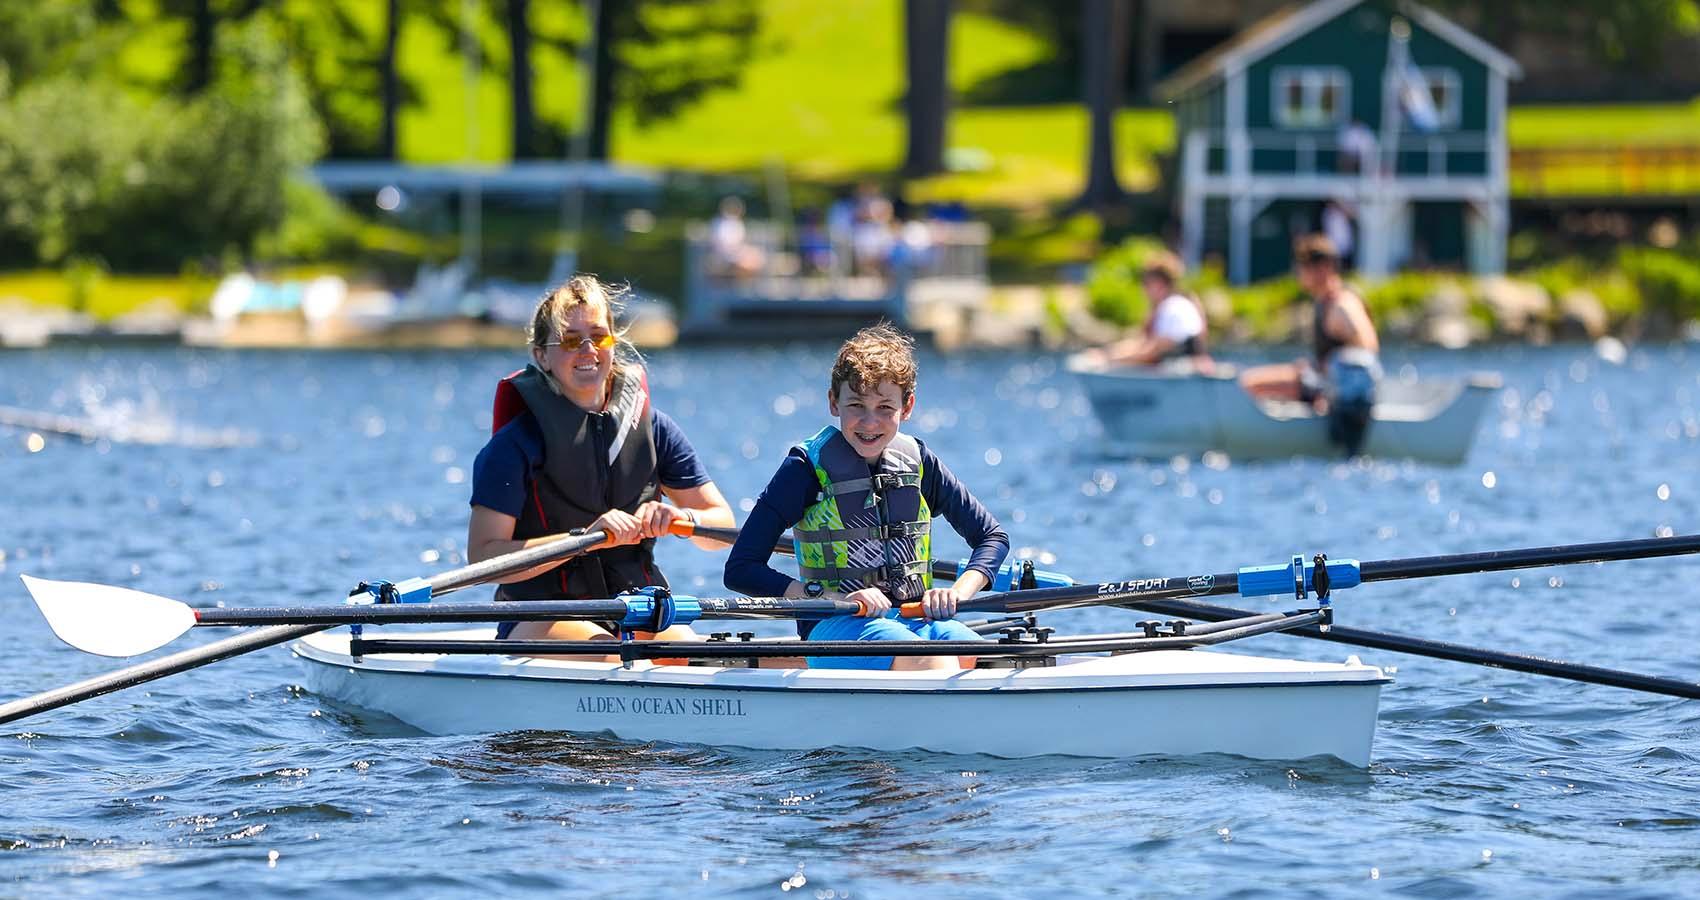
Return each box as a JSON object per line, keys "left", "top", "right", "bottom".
{"left": 0, "top": 19, "right": 323, "bottom": 271}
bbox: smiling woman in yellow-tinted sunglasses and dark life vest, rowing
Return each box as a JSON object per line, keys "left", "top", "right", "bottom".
{"left": 466, "top": 276, "right": 734, "bottom": 640}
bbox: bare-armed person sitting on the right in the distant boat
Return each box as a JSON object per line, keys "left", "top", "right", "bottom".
{"left": 1239, "top": 235, "right": 1382, "bottom": 453}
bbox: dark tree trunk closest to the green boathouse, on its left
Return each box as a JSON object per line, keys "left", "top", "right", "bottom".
{"left": 1074, "top": 0, "right": 1132, "bottom": 209}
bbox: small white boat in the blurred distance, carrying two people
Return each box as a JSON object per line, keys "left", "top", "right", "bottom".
{"left": 1068, "top": 356, "right": 1501, "bottom": 464}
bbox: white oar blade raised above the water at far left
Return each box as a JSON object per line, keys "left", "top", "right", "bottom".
{"left": 20, "top": 575, "right": 196, "bottom": 657}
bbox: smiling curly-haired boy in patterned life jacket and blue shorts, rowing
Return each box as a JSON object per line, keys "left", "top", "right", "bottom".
{"left": 726, "top": 323, "right": 1010, "bottom": 670}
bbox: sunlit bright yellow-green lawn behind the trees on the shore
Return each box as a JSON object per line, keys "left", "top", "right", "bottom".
{"left": 106, "top": 0, "right": 1700, "bottom": 209}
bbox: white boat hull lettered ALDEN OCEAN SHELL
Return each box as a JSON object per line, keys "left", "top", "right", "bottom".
{"left": 291, "top": 629, "right": 1391, "bottom": 766}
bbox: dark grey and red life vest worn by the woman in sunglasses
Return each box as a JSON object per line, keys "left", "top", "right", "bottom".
{"left": 491, "top": 366, "right": 666, "bottom": 601}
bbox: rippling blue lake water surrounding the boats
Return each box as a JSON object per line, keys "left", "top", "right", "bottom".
{"left": 0, "top": 345, "right": 1700, "bottom": 898}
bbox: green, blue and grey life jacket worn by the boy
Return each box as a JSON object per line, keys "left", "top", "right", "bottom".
{"left": 792, "top": 425, "right": 933, "bottom": 602}
